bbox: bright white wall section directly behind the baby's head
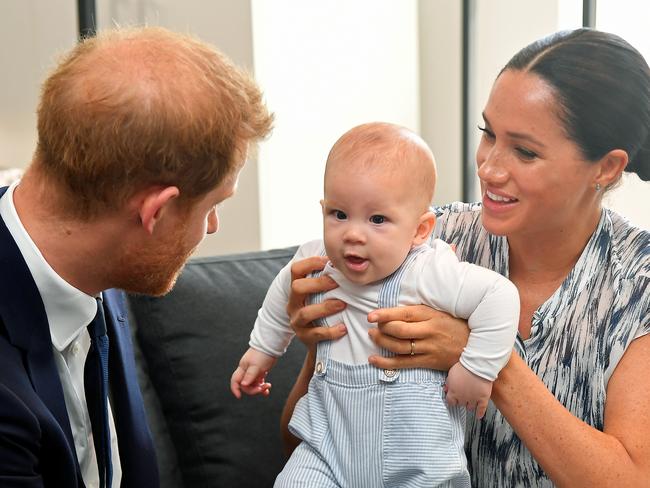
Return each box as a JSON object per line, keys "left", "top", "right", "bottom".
{"left": 252, "top": 0, "right": 419, "bottom": 248}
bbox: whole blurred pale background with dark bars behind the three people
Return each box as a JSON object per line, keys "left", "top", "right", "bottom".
{"left": 0, "top": 0, "right": 650, "bottom": 255}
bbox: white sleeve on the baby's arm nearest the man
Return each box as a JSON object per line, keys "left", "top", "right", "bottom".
{"left": 248, "top": 240, "right": 323, "bottom": 358}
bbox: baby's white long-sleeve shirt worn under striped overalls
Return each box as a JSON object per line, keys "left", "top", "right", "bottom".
{"left": 250, "top": 239, "right": 519, "bottom": 381}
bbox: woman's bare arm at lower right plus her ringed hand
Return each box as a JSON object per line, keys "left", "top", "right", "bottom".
{"left": 369, "top": 307, "right": 650, "bottom": 488}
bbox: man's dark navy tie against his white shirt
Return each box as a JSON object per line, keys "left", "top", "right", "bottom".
{"left": 84, "top": 298, "right": 113, "bottom": 488}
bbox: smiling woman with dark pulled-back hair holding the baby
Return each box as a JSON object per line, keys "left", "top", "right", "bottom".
{"left": 283, "top": 29, "right": 650, "bottom": 487}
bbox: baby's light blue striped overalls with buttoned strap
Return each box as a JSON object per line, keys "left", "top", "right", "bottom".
{"left": 275, "top": 248, "right": 470, "bottom": 488}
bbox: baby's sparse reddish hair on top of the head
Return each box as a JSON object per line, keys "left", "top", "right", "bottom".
{"left": 325, "top": 122, "right": 436, "bottom": 210}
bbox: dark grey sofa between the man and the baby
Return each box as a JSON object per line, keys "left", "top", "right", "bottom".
{"left": 129, "top": 248, "right": 305, "bottom": 488}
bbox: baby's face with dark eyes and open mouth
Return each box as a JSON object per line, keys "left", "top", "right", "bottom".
{"left": 322, "top": 169, "right": 423, "bottom": 284}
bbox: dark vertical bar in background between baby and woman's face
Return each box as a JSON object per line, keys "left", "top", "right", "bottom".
{"left": 462, "top": 0, "right": 476, "bottom": 202}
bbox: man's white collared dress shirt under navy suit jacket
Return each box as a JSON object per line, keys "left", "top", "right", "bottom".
{"left": 0, "top": 182, "right": 122, "bottom": 488}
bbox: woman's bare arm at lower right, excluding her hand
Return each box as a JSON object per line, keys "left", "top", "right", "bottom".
{"left": 492, "top": 336, "right": 650, "bottom": 488}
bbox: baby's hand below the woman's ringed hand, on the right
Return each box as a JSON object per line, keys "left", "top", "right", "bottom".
{"left": 445, "top": 363, "right": 492, "bottom": 419}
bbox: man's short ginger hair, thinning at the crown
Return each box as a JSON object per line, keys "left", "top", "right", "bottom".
{"left": 34, "top": 27, "right": 273, "bottom": 219}
